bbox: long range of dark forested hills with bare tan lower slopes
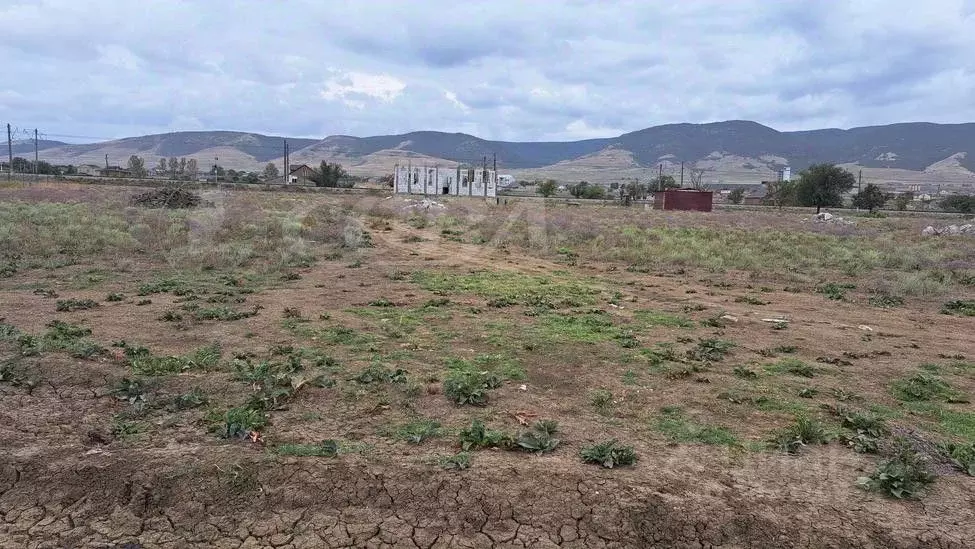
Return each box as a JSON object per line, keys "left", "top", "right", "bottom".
{"left": 22, "top": 120, "right": 975, "bottom": 187}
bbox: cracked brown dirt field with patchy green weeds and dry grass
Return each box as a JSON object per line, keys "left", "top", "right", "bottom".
{"left": 0, "top": 184, "right": 975, "bottom": 549}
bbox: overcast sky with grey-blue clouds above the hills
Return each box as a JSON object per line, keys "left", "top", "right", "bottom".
{"left": 0, "top": 0, "right": 975, "bottom": 141}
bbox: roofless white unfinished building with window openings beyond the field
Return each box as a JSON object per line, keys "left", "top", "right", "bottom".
{"left": 393, "top": 165, "right": 498, "bottom": 197}
